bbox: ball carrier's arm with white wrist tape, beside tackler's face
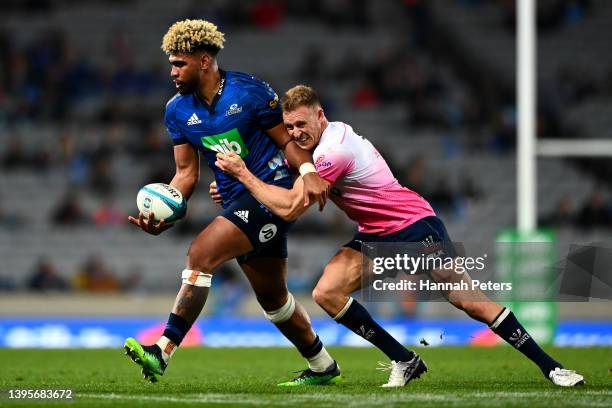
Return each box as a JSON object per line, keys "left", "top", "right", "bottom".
{"left": 266, "top": 123, "right": 330, "bottom": 210}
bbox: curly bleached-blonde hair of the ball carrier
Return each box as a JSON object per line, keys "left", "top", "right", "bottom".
{"left": 161, "top": 20, "right": 225, "bottom": 56}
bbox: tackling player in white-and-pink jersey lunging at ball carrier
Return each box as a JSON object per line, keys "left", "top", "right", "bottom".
{"left": 211, "top": 85, "right": 584, "bottom": 387}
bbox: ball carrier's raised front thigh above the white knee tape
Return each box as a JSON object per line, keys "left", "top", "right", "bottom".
{"left": 187, "top": 217, "right": 253, "bottom": 273}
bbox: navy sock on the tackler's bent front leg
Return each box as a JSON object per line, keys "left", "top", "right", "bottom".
{"left": 336, "top": 298, "right": 414, "bottom": 361}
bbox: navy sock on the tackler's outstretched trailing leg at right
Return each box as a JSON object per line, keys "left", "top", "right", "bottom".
{"left": 489, "top": 308, "right": 563, "bottom": 378}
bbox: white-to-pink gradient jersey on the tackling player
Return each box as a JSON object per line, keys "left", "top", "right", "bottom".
{"left": 313, "top": 122, "right": 435, "bottom": 235}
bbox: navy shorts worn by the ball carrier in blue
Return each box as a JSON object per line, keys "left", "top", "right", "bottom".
{"left": 220, "top": 191, "right": 292, "bottom": 263}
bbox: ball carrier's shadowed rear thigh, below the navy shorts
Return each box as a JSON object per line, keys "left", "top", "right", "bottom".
{"left": 240, "top": 257, "right": 288, "bottom": 310}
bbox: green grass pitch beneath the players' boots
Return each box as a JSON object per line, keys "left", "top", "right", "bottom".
{"left": 0, "top": 347, "right": 612, "bottom": 408}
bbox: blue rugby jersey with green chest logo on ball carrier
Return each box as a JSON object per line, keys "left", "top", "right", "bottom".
{"left": 165, "top": 70, "right": 292, "bottom": 208}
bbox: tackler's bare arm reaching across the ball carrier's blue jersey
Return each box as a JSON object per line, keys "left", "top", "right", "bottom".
{"left": 216, "top": 152, "right": 315, "bottom": 221}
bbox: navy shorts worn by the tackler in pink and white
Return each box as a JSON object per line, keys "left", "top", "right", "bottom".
{"left": 344, "top": 216, "right": 457, "bottom": 258}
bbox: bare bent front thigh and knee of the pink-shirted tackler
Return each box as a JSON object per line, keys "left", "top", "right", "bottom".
{"left": 315, "top": 247, "right": 362, "bottom": 296}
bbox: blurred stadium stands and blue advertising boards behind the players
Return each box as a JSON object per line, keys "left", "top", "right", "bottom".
{"left": 0, "top": 0, "right": 612, "bottom": 347}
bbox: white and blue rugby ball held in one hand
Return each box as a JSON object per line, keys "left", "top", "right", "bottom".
{"left": 136, "top": 183, "right": 187, "bottom": 224}
